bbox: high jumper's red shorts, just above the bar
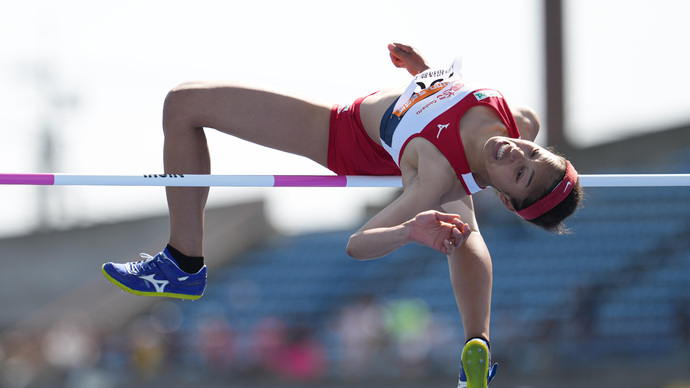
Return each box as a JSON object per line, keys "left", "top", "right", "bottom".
{"left": 328, "top": 97, "right": 400, "bottom": 175}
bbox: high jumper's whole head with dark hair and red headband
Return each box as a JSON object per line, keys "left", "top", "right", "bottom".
{"left": 484, "top": 137, "right": 583, "bottom": 232}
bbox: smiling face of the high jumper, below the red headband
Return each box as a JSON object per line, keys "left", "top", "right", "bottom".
{"left": 484, "top": 136, "right": 564, "bottom": 206}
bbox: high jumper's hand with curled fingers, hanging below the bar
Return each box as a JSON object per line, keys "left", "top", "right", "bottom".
{"left": 407, "top": 210, "right": 471, "bottom": 255}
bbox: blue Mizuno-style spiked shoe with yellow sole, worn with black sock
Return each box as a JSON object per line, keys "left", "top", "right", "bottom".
{"left": 103, "top": 249, "right": 206, "bottom": 300}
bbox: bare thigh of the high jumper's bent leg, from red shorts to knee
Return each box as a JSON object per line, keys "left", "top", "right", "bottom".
{"left": 166, "top": 82, "right": 332, "bottom": 166}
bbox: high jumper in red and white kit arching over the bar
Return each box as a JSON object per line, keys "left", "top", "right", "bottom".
{"left": 103, "top": 44, "right": 582, "bottom": 388}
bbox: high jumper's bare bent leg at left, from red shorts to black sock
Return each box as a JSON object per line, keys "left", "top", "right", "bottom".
{"left": 163, "top": 83, "right": 331, "bottom": 256}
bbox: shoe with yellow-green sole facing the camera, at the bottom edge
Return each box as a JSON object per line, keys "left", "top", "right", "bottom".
{"left": 458, "top": 338, "right": 498, "bottom": 388}
